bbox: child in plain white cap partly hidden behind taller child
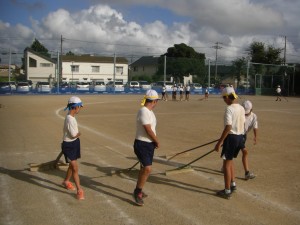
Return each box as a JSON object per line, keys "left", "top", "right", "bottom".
{"left": 242, "top": 100, "right": 258, "bottom": 180}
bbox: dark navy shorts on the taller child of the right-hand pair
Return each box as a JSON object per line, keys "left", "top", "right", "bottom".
{"left": 221, "top": 134, "right": 245, "bottom": 160}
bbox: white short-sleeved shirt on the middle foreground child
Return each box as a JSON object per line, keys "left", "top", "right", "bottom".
{"left": 135, "top": 106, "right": 156, "bottom": 142}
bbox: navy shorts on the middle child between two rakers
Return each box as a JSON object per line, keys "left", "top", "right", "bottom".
{"left": 133, "top": 139, "right": 155, "bottom": 167}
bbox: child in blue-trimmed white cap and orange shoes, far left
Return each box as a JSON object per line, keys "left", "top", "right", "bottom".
{"left": 61, "top": 96, "right": 84, "bottom": 200}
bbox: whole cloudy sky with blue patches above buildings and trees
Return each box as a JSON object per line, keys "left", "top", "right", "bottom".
{"left": 0, "top": 0, "right": 300, "bottom": 64}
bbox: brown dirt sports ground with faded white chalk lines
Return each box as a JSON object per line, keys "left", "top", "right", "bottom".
{"left": 0, "top": 95, "right": 300, "bottom": 225}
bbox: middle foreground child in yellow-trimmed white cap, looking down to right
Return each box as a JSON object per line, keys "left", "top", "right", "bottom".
{"left": 133, "top": 89, "right": 159, "bottom": 206}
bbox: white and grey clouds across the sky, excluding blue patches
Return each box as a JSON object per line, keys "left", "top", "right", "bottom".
{"left": 0, "top": 0, "right": 300, "bottom": 64}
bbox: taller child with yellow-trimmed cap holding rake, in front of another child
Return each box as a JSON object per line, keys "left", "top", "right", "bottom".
{"left": 215, "top": 87, "right": 245, "bottom": 199}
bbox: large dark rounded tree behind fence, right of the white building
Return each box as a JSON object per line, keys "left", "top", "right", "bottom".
{"left": 157, "top": 43, "right": 205, "bottom": 82}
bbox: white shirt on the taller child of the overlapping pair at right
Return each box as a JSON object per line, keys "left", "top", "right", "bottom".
{"left": 224, "top": 104, "right": 245, "bottom": 135}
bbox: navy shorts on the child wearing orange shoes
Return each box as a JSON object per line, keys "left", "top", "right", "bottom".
{"left": 61, "top": 138, "right": 81, "bottom": 163}
